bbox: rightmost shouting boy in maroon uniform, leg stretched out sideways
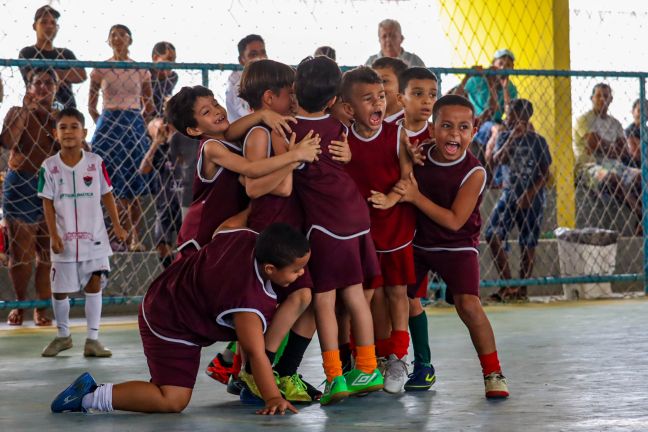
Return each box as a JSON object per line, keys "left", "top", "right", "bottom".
{"left": 395, "top": 95, "right": 509, "bottom": 398}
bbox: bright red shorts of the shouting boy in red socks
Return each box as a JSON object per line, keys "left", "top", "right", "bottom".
{"left": 364, "top": 243, "right": 416, "bottom": 289}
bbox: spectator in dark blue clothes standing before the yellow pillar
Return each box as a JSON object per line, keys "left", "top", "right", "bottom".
{"left": 486, "top": 99, "right": 551, "bottom": 301}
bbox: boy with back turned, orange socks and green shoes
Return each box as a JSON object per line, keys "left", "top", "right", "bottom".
{"left": 293, "top": 56, "right": 383, "bottom": 405}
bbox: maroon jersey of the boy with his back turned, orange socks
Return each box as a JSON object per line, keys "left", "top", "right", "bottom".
{"left": 291, "top": 115, "right": 370, "bottom": 238}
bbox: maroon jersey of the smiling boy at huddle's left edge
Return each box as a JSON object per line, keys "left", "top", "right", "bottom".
{"left": 178, "top": 139, "right": 249, "bottom": 249}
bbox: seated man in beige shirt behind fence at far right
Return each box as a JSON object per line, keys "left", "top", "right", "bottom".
{"left": 573, "top": 83, "right": 641, "bottom": 233}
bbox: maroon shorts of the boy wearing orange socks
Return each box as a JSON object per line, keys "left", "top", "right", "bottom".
{"left": 308, "top": 229, "right": 380, "bottom": 293}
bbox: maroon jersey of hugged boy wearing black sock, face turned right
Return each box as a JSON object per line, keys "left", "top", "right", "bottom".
{"left": 243, "top": 126, "right": 304, "bottom": 232}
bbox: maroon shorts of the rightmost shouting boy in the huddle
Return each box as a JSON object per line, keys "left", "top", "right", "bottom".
{"left": 407, "top": 248, "right": 479, "bottom": 304}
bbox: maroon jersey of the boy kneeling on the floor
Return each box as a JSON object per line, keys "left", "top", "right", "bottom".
{"left": 142, "top": 229, "right": 277, "bottom": 346}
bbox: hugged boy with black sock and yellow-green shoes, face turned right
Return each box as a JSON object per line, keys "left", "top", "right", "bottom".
{"left": 234, "top": 60, "right": 332, "bottom": 402}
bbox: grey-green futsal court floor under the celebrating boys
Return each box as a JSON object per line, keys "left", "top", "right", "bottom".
{"left": 0, "top": 298, "right": 648, "bottom": 432}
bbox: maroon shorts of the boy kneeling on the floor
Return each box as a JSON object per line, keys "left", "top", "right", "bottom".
{"left": 137, "top": 305, "right": 201, "bottom": 389}
